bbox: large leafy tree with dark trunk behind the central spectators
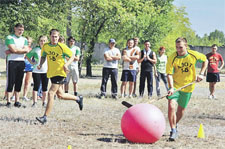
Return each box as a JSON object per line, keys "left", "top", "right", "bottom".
{"left": 75, "top": 0, "right": 172, "bottom": 76}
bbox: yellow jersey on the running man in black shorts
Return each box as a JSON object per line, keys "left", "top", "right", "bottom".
{"left": 41, "top": 43, "right": 72, "bottom": 78}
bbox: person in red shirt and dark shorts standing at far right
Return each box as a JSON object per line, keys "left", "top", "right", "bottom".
{"left": 206, "top": 44, "right": 224, "bottom": 99}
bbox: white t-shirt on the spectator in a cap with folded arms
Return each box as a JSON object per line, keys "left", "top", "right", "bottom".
{"left": 103, "top": 47, "right": 120, "bottom": 68}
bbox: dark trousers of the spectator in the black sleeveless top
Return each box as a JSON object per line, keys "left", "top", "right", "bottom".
{"left": 139, "top": 71, "right": 153, "bottom": 96}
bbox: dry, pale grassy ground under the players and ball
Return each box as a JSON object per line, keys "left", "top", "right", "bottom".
{"left": 0, "top": 58, "right": 225, "bottom": 149}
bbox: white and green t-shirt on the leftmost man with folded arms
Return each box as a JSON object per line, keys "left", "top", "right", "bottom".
{"left": 5, "top": 34, "right": 28, "bottom": 61}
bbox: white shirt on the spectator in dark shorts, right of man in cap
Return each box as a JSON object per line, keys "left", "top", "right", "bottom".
{"left": 123, "top": 48, "right": 139, "bottom": 70}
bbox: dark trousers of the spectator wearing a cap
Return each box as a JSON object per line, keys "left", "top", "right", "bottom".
{"left": 101, "top": 68, "right": 118, "bottom": 96}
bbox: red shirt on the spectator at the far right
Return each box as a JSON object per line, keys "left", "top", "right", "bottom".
{"left": 206, "top": 53, "right": 223, "bottom": 73}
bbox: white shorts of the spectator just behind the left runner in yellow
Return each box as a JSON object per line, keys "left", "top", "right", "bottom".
{"left": 65, "top": 65, "right": 79, "bottom": 84}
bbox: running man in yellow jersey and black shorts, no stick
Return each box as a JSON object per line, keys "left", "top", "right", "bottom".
{"left": 36, "top": 29, "right": 83, "bottom": 124}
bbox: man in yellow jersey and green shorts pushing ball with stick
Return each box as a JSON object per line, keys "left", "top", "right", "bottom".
{"left": 166, "top": 37, "right": 208, "bottom": 141}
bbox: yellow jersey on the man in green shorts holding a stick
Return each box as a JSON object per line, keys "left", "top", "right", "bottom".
{"left": 166, "top": 50, "right": 207, "bottom": 92}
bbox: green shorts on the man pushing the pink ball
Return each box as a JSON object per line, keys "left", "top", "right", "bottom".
{"left": 167, "top": 91, "right": 192, "bottom": 108}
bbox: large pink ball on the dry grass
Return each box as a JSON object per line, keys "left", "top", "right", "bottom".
{"left": 121, "top": 103, "right": 166, "bottom": 143}
